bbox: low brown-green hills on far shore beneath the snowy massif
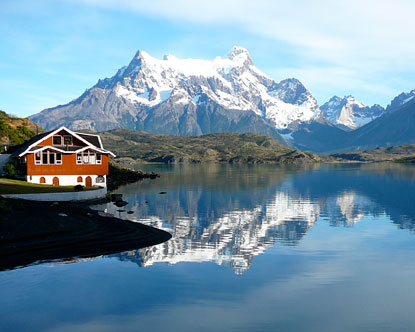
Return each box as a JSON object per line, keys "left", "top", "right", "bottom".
{"left": 100, "top": 129, "right": 321, "bottom": 163}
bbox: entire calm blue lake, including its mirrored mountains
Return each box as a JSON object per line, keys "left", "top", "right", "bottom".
{"left": 0, "top": 164, "right": 415, "bottom": 332}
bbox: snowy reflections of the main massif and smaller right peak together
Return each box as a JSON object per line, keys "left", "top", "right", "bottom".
{"left": 110, "top": 190, "right": 376, "bottom": 274}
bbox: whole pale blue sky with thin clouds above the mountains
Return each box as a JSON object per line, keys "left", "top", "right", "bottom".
{"left": 0, "top": 0, "right": 415, "bottom": 116}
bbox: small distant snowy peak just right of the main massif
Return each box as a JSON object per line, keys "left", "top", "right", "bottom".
{"left": 320, "top": 96, "right": 385, "bottom": 130}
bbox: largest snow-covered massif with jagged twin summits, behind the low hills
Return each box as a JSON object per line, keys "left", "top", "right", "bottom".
{"left": 31, "top": 46, "right": 321, "bottom": 135}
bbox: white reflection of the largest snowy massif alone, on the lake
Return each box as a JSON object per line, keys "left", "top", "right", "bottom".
{"left": 111, "top": 192, "right": 320, "bottom": 274}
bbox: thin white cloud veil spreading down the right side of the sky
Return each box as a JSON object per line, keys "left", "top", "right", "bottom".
{"left": 70, "top": 0, "right": 415, "bottom": 103}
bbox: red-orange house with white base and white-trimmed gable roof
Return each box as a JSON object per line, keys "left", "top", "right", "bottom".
{"left": 11, "top": 127, "right": 115, "bottom": 187}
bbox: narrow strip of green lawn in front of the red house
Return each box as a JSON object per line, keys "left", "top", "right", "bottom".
{"left": 0, "top": 178, "right": 97, "bottom": 195}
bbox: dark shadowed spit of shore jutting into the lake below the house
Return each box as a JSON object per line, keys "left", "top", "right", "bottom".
{"left": 0, "top": 198, "right": 171, "bottom": 271}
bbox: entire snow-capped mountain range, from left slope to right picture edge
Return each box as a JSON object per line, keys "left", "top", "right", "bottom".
{"left": 29, "top": 46, "right": 415, "bottom": 152}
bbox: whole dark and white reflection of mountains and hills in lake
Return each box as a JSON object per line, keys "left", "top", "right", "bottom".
{"left": 95, "top": 164, "right": 415, "bottom": 274}
